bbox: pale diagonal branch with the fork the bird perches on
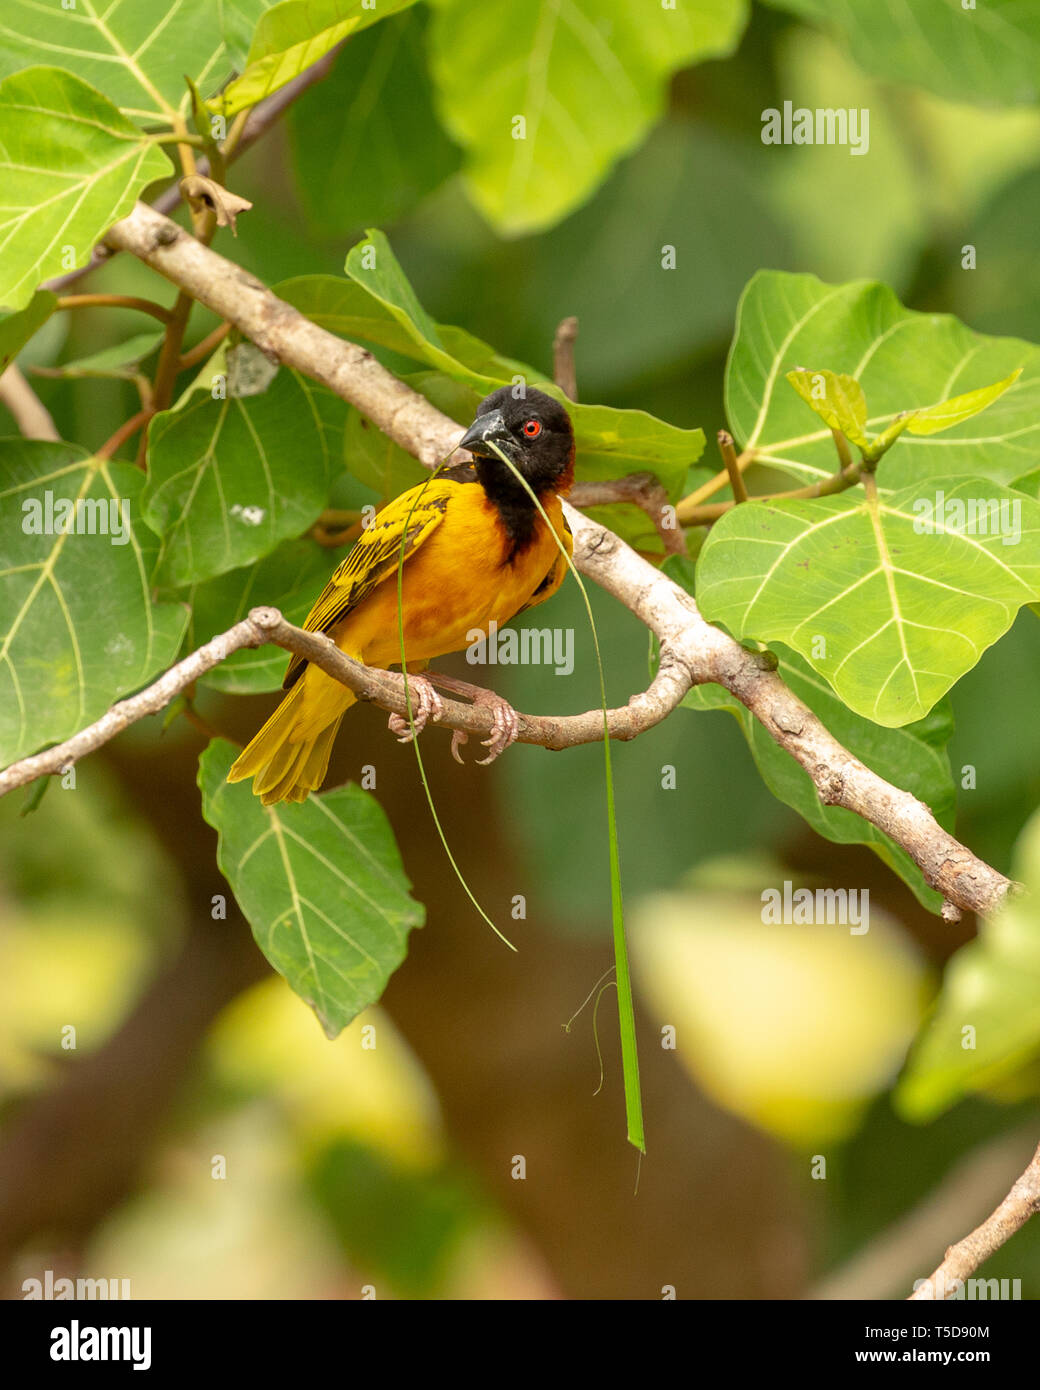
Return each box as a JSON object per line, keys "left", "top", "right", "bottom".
{"left": 12, "top": 195, "right": 989, "bottom": 913}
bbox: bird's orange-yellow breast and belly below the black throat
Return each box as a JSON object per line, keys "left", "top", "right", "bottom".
{"left": 332, "top": 482, "right": 570, "bottom": 667}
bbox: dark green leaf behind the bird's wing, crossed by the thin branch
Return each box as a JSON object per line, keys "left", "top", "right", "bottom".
{"left": 179, "top": 537, "right": 333, "bottom": 695}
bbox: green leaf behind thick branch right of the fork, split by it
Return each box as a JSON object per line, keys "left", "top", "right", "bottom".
{"left": 666, "top": 559, "right": 955, "bottom": 912}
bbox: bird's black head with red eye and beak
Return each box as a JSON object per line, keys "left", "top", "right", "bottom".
{"left": 460, "top": 386, "right": 574, "bottom": 500}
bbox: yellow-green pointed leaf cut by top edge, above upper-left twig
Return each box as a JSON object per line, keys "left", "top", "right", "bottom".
{"left": 210, "top": 0, "right": 414, "bottom": 115}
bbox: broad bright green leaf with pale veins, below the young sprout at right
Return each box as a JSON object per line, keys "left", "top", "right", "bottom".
{"left": 697, "top": 477, "right": 1040, "bottom": 728}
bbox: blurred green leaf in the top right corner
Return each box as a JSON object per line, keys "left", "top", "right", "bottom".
{"left": 766, "top": 0, "right": 1040, "bottom": 106}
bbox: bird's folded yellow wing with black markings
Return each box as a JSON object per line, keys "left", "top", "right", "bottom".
{"left": 282, "top": 478, "right": 457, "bottom": 689}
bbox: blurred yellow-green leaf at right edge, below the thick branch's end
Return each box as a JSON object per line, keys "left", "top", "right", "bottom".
{"left": 894, "top": 815, "right": 1040, "bottom": 1122}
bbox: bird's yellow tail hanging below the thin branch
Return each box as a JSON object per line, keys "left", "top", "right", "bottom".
{"left": 228, "top": 667, "right": 356, "bottom": 806}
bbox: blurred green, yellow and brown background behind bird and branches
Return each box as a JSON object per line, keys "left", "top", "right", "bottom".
{"left": 0, "top": 6, "right": 1040, "bottom": 1298}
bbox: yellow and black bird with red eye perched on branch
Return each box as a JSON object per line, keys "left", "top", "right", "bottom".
{"left": 228, "top": 386, "right": 574, "bottom": 806}
